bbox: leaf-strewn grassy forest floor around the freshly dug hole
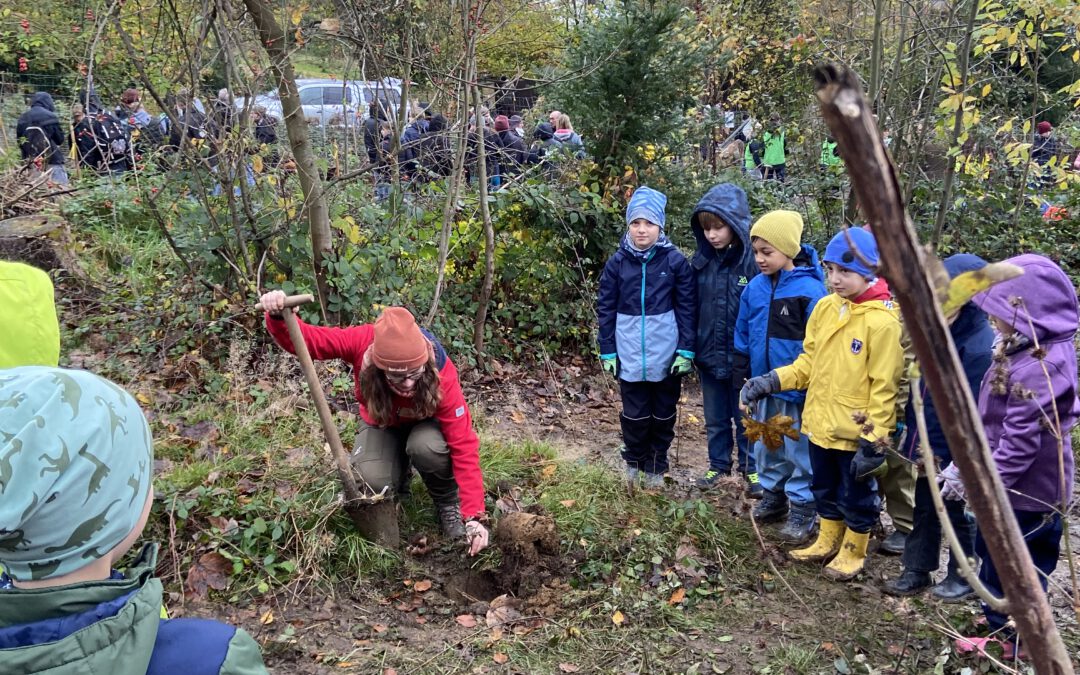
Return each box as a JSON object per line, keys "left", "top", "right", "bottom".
{"left": 122, "top": 347, "right": 1080, "bottom": 675}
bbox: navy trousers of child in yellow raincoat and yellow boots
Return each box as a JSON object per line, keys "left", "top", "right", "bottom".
{"left": 810, "top": 442, "right": 881, "bottom": 535}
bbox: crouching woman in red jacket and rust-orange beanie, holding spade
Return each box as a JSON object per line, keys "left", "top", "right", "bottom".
{"left": 260, "top": 291, "right": 488, "bottom": 555}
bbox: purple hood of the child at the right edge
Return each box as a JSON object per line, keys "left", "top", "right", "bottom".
{"left": 974, "top": 253, "right": 1080, "bottom": 342}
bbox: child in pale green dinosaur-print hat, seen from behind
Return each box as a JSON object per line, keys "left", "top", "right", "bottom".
{"left": 0, "top": 366, "right": 267, "bottom": 675}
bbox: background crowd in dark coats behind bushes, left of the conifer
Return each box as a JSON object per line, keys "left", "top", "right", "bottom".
{"left": 16, "top": 81, "right": 585, "bottom": 197}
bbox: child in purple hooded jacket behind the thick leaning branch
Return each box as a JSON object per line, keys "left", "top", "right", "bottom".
{"left": 939, "top": 254, "right": 1080, "bottom": 658}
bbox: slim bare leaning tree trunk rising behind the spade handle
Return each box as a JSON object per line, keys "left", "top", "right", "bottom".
{"left": 244, "top": 0, "right": 337, "bottom": 323}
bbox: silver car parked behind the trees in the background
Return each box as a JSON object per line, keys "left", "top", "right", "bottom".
{"left": 235, "top": 78, "right": 402, "bottom": 126}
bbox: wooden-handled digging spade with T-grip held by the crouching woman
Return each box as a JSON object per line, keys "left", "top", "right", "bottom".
{"left": 255, "top": 295, "right": 401, "bottom": 549}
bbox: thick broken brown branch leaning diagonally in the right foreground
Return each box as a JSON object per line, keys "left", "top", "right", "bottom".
{"left": 814, "top": 64, "right": 1074, "bottom": 675}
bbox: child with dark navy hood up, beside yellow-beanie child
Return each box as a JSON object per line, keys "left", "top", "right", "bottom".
{"left": 690, "top": 183, "right": 761, "bottom": 497}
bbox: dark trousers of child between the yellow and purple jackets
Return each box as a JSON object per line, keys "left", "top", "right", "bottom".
{"left": 903, "top": 476, "right": 975, "bottom": 575}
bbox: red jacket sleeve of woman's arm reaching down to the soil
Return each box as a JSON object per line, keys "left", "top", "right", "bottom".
{"left": 435, "top": 359, "right": 485, "bottom": 518}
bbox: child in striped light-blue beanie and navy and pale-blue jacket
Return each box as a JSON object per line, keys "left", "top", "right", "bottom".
{"left": 596, "top": 186, "right": 694, "bottom": 488}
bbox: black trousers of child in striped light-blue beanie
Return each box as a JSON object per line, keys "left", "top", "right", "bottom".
{"left": 619, "top": 375, "right": 683, "bottom": 474}
